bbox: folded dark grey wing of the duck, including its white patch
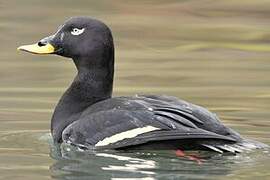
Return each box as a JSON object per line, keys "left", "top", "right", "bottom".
{"left": 62, "top": 96, "right": 237, "bottom": 149}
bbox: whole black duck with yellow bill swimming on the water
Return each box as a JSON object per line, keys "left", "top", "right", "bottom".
{"left": 18, "top": 17, "right": 264, "bottom": 153}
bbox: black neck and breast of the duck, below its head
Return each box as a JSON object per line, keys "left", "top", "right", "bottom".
{"left": 51, "top": 48, "right": 114, "bottom": 142}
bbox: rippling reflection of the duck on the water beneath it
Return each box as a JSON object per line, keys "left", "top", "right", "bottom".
{"left": 51, "top": 143, "right": 270, "bottom": 180}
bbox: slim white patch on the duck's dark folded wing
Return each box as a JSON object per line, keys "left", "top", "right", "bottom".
{"left": 95, "top": 126, "right": 160, "bottom": 147}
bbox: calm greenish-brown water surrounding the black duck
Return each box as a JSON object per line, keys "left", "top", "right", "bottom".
{"left": 0, "top": 0, "right": 270, "bottom": 180}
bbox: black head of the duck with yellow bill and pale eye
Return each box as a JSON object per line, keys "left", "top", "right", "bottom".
{"left": 18, "top": 17, "right": 114, "bottom": 69}
